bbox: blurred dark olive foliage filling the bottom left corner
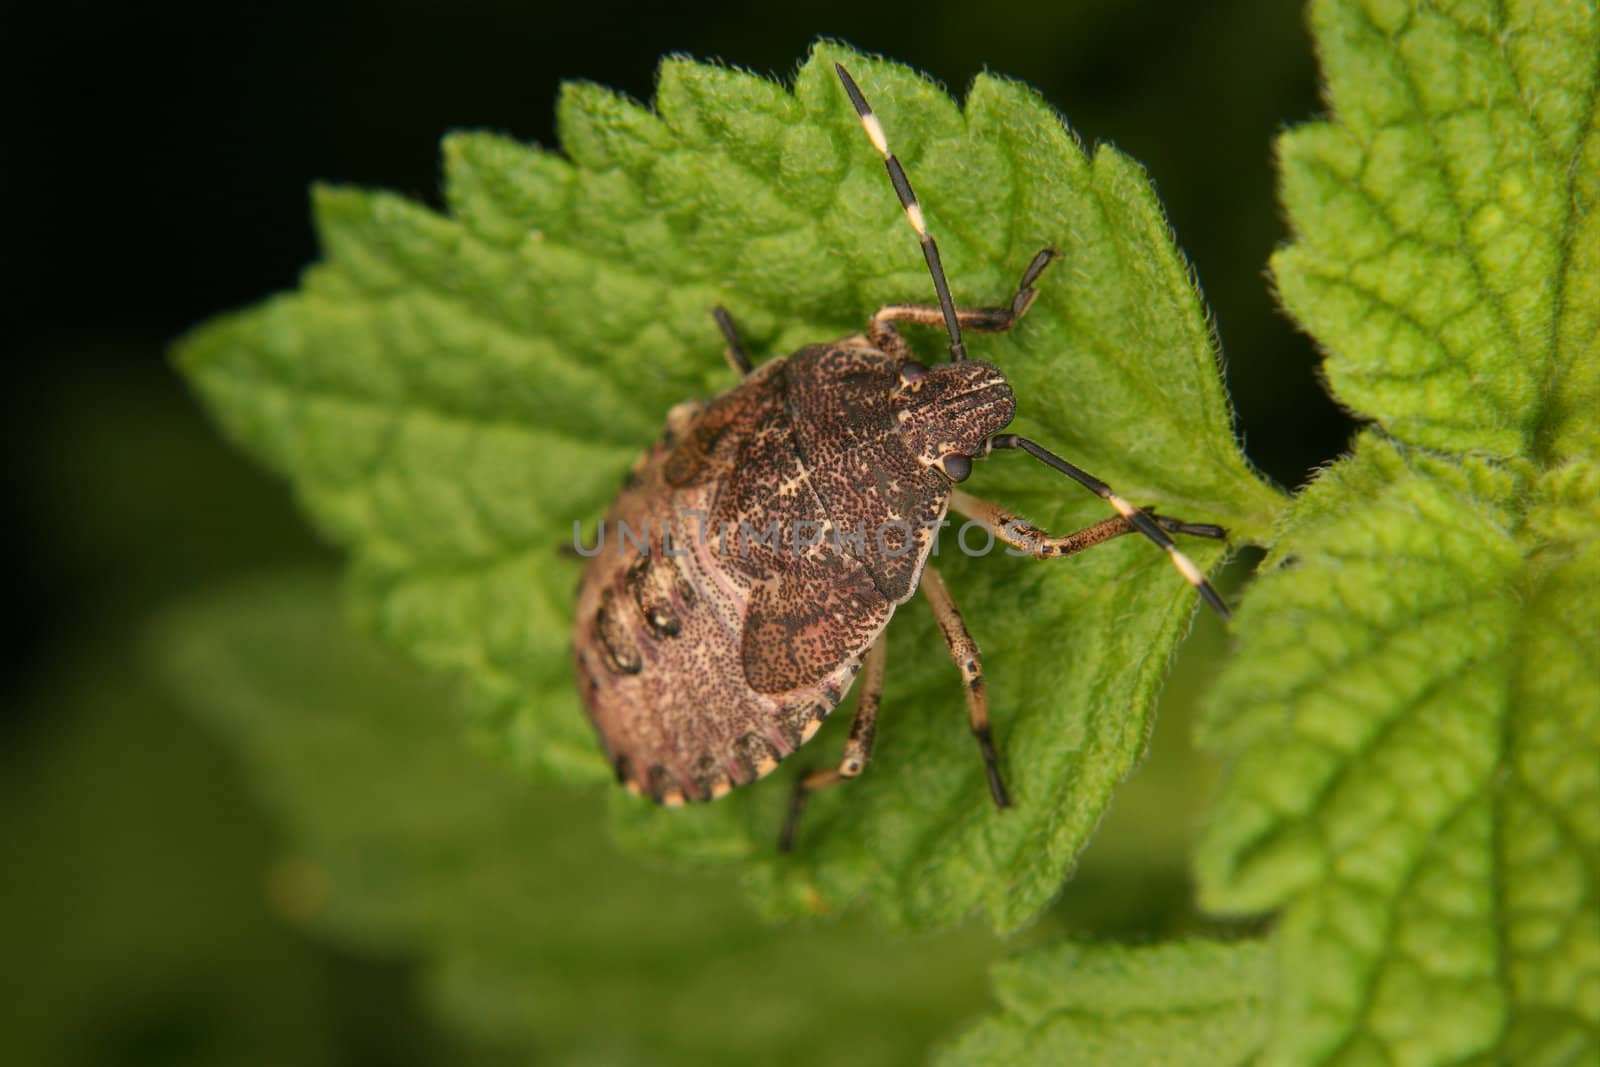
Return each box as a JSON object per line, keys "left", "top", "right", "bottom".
{"left": 0, "top": 645, "right": 462, "bottom": 1067}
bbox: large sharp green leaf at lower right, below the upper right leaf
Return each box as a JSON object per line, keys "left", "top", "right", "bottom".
{"left": 1200, "top": 437, "right": 1600, "bottom": 1064}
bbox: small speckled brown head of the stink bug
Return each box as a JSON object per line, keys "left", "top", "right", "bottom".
{"left": 894, "top": 360, "right": 1016, "bottom": 482}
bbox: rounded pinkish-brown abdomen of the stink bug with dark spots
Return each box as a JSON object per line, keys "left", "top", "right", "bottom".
{"left": 573, "top": 396, "right": 893, "bottom": 803}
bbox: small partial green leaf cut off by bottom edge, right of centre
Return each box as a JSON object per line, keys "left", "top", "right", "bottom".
{"left": 938, "top": 941, "right": 1272, "bottom": 1067}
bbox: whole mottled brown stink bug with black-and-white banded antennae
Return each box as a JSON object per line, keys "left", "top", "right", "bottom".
{"left": 573, "top": 64, "right": 1227, "bottom": 848}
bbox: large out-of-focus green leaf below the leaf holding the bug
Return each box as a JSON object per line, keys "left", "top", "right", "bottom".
{"left": 150, "top": 577, "right": 994, "bottom": 1064}
